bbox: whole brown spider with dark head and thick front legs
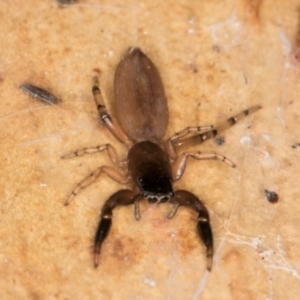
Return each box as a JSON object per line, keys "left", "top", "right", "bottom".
{"left": 63, "top": 48, "right": 260, "bottom": 270}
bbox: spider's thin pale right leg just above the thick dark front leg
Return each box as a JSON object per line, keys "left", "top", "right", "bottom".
{"left": 173, "top": 151, "right": 236, "bottom": 181}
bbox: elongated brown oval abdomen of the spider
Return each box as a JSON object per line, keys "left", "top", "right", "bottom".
{"left": 114, "top": 48, "right": 169, "bottom": 142}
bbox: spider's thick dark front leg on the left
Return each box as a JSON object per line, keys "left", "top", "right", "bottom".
{"left": 94, "top": 190, "right": 135, "bottom": 268}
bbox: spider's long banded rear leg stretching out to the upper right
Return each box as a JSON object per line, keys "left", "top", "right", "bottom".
{"left": 171, "top": 105, "right": 261, "bottom": 152}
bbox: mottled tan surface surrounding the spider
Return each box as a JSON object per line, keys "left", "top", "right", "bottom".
{"left": 0, "top": 0, "right": 300, "bottom": 300}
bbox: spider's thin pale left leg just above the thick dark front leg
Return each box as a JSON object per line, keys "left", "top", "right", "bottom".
{"left": 65, "top": 166, "right": 131, "bottom": 205}
